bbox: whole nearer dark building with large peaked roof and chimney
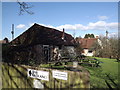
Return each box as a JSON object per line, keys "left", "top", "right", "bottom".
{"left": 10, "top": 23, "right": 75, "bottom": 64}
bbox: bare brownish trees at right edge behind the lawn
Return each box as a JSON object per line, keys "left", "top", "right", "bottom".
{"left": 92, "top": 36, "right": 118, "bottom": 58}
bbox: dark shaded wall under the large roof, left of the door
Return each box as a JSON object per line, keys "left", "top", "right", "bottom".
{"left": 7, "top": 45, "right": 52, "bottom": 65}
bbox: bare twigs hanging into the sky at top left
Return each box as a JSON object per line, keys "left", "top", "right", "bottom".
{"left": 17, "top": 0, "right": 34, "bottom": 15}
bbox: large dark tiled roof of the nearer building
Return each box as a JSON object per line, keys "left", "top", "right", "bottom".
{"left": 12, "top": 24, "right": 74, "bottom": 45}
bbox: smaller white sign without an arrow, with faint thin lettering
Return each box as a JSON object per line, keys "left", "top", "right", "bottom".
{"left": 52, "top": 71, "right": 68, "bottom": 80}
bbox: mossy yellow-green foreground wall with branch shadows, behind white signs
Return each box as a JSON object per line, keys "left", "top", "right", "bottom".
{"left": 2, "top": 63, "right": 90, "bottom": 89}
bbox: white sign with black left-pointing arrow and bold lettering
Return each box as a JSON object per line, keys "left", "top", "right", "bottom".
{"left": 28, "top": 69, "right": 49, "bottom": 81}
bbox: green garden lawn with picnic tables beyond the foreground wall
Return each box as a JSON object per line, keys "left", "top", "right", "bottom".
{"left": 40, "top": 57, "right": 119, "bottom": 88}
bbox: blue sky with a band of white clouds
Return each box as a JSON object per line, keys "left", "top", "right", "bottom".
{"left": 0, "top": 2, "right": 118, "bottom": 40}
